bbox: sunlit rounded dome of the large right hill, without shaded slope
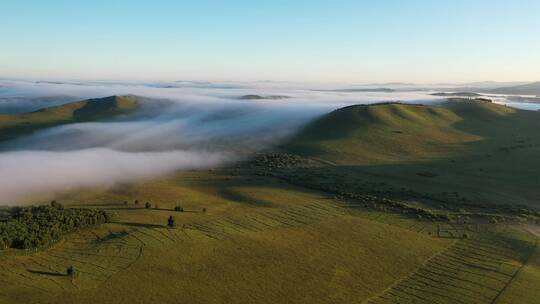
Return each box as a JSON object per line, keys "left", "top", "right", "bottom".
{"left": 285, "top": 104, "right": 479, "bottom": 164}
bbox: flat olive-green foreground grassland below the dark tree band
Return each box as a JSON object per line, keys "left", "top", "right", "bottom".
{"left": 0, "top": 171, "right": 538, "bottom": 303}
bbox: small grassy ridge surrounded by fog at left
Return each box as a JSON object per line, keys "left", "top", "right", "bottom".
{"left": 0, "top": 96, "right": 138, "bottom": 140}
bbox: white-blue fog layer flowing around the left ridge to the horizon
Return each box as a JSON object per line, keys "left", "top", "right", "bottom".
{"left": 0, "top": 81, "right": 528, "bottom": 205}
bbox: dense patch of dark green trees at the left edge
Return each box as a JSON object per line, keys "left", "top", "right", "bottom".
{"left": 0, "top": 201, "right": 110, "bottom": 249}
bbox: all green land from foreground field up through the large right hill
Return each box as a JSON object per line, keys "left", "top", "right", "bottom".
{"left": 0, "top": 100, "right": 540, "bottom": 304}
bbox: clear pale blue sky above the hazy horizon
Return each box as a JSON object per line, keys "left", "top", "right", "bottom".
{"left": 0, "top": 0, "right": 540, "bottom": 83}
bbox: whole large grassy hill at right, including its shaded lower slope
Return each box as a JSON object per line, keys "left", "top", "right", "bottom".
{"left": 282, "top": 99, "right": 540, "bottom": 206}
